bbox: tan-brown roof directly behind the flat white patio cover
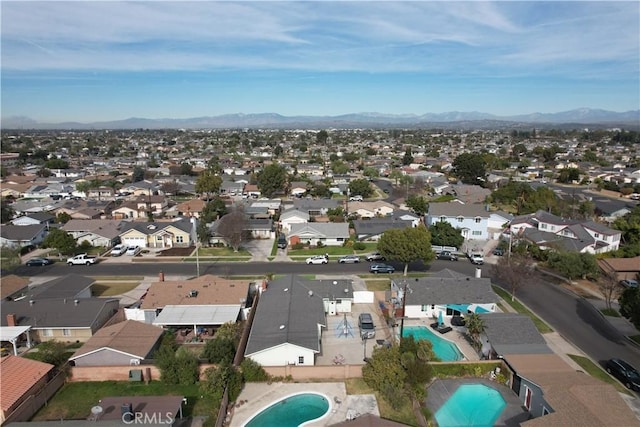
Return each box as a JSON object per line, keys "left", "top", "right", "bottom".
{"left": 140, "top": 274, "right": 249, "bottom": 309}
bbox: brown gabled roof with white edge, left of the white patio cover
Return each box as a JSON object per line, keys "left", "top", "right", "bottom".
{"left": 71, "top": 320, "right": 162, "bottom": 359}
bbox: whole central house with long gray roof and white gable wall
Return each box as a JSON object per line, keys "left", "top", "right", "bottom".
{"left": 244, "top": 276, "right": 327, "bottom": 366}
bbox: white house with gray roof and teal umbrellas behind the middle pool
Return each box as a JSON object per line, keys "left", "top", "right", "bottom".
{"left": 391, "top": 269, "right": 499, "bottom": 320}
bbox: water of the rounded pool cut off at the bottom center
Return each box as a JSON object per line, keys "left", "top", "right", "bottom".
{"left": 245, "top": 393, "right": 329, "bottom": 427}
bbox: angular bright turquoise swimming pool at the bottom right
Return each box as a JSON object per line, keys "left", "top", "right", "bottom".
{"left": 435, "top": 384, "right": 507, "bottom": 427}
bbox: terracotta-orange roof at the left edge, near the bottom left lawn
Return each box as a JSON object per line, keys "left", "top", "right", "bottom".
{"left": 0, "top": 356, "right": 54, "bottom": 411}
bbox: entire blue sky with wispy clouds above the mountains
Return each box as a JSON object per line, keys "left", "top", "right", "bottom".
{"left": 0, "top": 0, "right": 640, "bottom": 122}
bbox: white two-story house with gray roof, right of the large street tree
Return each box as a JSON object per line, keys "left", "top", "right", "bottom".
{"left": 427, "top": 201, "right": 490, "bottom": 240}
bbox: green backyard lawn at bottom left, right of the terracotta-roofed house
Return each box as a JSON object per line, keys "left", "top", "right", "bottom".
{"left": 33, "top": 381, "right": 213, "bottom": 421}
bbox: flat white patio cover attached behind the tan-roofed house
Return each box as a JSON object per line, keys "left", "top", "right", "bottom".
{"left": 153, "top": 304, "right": 242, "bottom": 329}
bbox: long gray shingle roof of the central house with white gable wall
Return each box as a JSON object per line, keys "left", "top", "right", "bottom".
{"left": 245, "top": 276, "right": 326, "bottom": 356}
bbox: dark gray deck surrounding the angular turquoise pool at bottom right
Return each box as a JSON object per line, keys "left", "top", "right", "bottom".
{"left": 425, "top": 378, "right": 530, "bottom": 427}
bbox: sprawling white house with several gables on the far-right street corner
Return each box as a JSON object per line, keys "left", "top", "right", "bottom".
{"left": 510, "top": 210, "right": 621, "bottom": 254}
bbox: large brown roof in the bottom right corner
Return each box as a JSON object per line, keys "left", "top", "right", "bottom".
{"left": 504, "top": 354, "right": 638, "bottom": 427}
